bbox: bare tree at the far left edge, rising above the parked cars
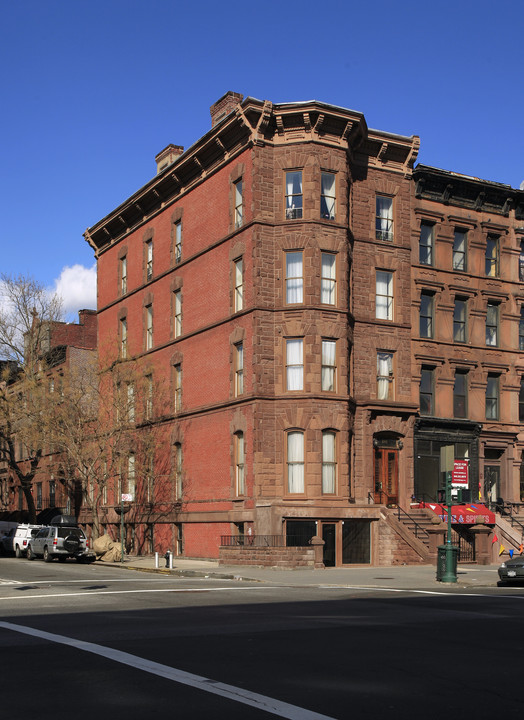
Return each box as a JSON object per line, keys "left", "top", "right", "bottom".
{"left": 0, "top": 274, "right": 62, "bottom": 522}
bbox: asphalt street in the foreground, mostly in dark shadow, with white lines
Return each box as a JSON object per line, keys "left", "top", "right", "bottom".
{"left": 0, "top": 558, "right": 524, "bottom": 720}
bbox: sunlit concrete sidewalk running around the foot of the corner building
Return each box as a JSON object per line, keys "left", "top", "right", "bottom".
{"left": 98, "top": 557, "right": 504, "bottom": 591}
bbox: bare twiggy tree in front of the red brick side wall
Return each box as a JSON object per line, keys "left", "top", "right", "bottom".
{"left": 47, "top": 356, "right": 170, "bottom": 537}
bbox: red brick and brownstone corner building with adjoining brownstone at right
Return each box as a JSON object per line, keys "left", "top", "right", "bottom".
{"left": 85, "top": 93, "right": 524, "bottom": 565}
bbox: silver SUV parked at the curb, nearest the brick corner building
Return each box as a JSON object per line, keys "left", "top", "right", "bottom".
{"left": 27, "top": 516, "right": 94, "bottom": 562}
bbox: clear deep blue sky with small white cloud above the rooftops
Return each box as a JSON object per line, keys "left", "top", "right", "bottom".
{"left": 0, "top": 0, "right": 524, "bottom": 312}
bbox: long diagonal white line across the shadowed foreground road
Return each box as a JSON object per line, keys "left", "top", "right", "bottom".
{"left": 0, "top": 621, "right": 334, "bottom": 720}
